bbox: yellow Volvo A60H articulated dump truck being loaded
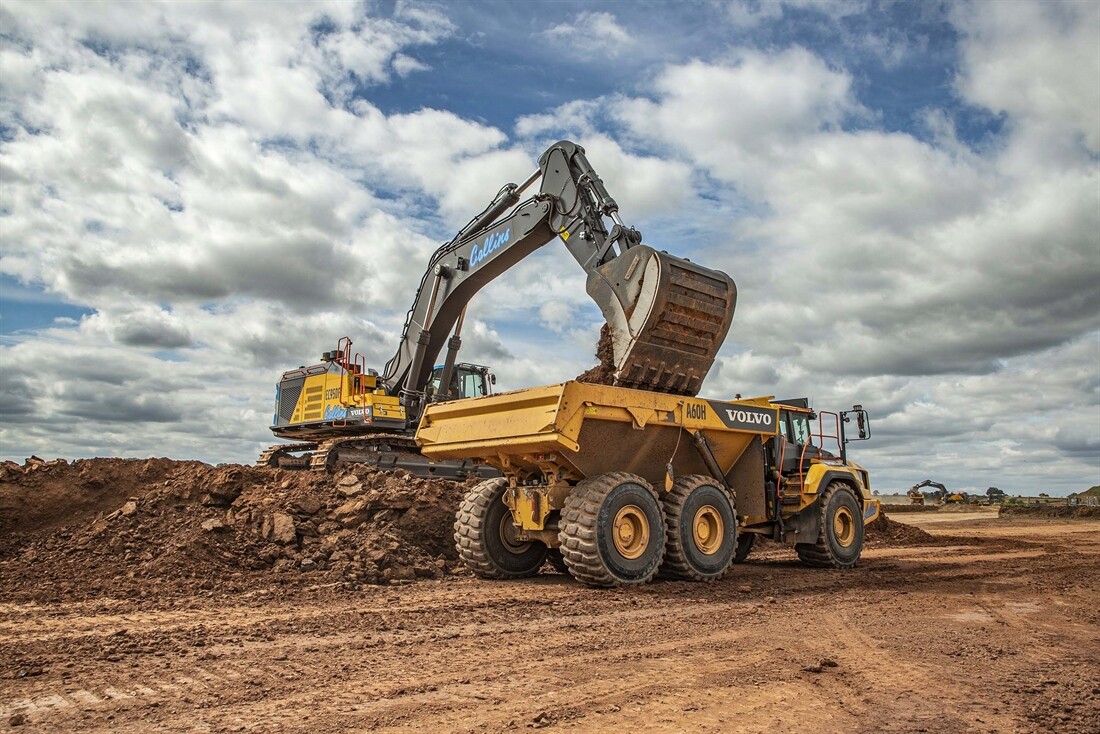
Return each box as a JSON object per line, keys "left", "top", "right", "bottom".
{"left": 416, "top": 382, "right": 879, "bottom": 587}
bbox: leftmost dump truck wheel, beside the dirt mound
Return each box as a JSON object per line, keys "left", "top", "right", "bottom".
{"left": 454, "top": 476, "right": 547, "bottom": 579}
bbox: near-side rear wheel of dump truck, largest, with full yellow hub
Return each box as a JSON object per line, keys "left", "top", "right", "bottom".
{"left": 558, "top": 471, "right": 664, "bottom": 587}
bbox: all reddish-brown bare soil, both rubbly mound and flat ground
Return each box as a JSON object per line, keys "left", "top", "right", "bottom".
{"left": 0, "top": 460, "right": 1100, "bottom": 734}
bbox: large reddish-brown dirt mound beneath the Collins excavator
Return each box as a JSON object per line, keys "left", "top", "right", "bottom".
{"left": 0, "top": 459, "right": 465, "bottom": 601}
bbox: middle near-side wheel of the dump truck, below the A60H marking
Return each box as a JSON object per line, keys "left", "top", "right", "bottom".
{"left": 661, "top": 474, "right": 737, "bottom": 581}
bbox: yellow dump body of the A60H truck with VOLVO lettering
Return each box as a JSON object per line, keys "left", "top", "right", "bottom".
{"left": 417, "top": 382, "right": 779, "bottom": 484}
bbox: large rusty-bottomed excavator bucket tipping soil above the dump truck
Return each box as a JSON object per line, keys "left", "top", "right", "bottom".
{"left": 586, "top": 244, "right": 737, "bottom": 395}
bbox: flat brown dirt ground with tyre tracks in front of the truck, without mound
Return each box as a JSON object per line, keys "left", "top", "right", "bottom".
{"left": 0, "top": 516, "right": 1100, "bottom": 733}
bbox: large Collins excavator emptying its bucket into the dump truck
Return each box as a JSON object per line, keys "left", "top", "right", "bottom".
{"left": 257, "top": 141, "right": 737, "bottom": 479}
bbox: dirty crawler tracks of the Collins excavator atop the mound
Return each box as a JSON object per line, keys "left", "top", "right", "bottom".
{"left": 256, "top": 434, "right": 501, "bottom": 481}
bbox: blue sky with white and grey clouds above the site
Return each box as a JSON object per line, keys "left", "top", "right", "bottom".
{"left": 0, "top": 0, "right": 1100, "bottom": 495}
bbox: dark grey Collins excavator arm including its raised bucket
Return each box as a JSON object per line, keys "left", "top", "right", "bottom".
{"left": 383, "top": 141, "right": 737, "bottom": 417}
